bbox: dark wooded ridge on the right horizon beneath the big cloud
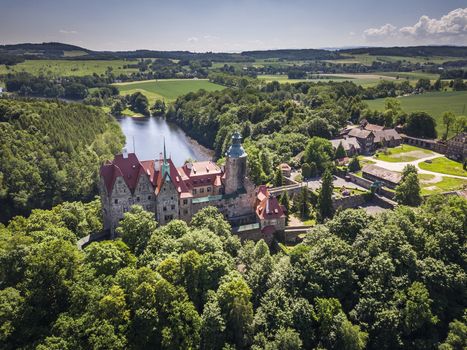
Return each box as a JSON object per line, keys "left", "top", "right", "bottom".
{"left": 339, "top": 46, "right": 467, "bottom": 57}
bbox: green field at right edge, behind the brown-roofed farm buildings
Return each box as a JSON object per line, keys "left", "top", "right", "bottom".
{"left": 365, "top": 91, "right": 467, "bottom": 136}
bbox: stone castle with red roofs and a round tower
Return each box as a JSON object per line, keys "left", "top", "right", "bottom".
{"left": 99, "top": 133, "right": 285, "bottom": 239}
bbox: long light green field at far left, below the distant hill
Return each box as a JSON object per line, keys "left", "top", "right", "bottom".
{"left": 0, "top": 59, "right": 138, "bottom": 76}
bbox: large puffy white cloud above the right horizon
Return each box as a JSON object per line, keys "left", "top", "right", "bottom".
{"left": 363, "top": 8, "right": 467, "bottom": 45}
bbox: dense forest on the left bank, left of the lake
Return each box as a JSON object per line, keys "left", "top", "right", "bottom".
{"left": 0, "top": 99, "right": 124, "bottom": 222}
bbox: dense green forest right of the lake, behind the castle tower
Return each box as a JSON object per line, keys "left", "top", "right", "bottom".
{"left": 166, "top": 76, "right": 446, "bottom": 184}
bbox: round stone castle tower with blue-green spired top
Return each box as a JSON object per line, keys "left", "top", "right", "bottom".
{"left": 225, "top": 132, "right": 247, "bottom": 194}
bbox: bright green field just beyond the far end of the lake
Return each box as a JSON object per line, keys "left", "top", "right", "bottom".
{"left": 114, "top": 79, "right": 224, "bottom": 104}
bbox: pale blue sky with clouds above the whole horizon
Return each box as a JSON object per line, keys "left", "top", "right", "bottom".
{"left": 0, "top": 0, "right": 467, "bottom": 52}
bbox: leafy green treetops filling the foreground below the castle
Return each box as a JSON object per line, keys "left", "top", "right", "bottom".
{"left": 0, "top": 196, "right": 467, "bottom": 350}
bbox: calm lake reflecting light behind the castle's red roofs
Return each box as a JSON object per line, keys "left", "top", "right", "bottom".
{"left": 117, "top": 117, "right": 214, "bottom": 166}
